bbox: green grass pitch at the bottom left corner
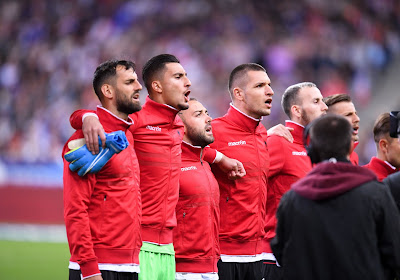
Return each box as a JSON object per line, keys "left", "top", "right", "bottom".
{"left": 0, "top": 240, "right": 70, "bottom": 280}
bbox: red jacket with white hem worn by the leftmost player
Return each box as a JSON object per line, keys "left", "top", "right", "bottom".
{"left": 63, "top": 107, "right": 141, "bottom": 277}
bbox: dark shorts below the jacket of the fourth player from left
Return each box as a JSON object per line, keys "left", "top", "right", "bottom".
{"left": 218, "top": 260, "right": 264, "bottom": 280}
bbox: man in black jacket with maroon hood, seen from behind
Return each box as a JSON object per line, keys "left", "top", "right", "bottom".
{"left": 271, "top": 115, "right": 400, "bottom": 280}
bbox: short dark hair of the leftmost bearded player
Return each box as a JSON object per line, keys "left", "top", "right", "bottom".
{"left": 93, "top": 59, "right": 136, "bottom": 101}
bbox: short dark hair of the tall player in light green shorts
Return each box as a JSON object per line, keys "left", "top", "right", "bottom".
{"left": 142, "top": 54, "right": 180, "bottom": 91}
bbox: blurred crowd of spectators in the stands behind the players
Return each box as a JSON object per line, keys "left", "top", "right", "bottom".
{"left": 0, "top": 0, "right": 400, "bottom": 163}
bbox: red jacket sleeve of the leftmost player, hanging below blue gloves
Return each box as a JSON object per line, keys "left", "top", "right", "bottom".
{"left": 63, "top": 141, "right": 100, "bottom": 277}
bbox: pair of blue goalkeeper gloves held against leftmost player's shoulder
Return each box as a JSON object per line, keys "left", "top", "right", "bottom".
{"left": 64, "top": 130, "right": 129, "bottom": 176}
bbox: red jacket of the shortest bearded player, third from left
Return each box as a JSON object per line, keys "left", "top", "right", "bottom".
{"left": 174, "top": 142, "right": 219, "bottom": 273}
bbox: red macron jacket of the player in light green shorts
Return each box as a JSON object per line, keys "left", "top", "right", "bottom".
{"left": 70, "top": 97, "right": 215, "bottom": 244}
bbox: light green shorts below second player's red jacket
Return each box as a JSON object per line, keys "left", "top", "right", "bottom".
{"left": 139, "top": 242, "right": 175, "bottom": 280}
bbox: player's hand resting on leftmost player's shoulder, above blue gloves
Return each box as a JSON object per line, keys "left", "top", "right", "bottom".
{"left": 82, "top": 116, "right": 106, "bottom": 155}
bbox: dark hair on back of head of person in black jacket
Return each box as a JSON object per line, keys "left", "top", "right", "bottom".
{"left": 310, "top": 114, "right": 353, "bottom": 161}
